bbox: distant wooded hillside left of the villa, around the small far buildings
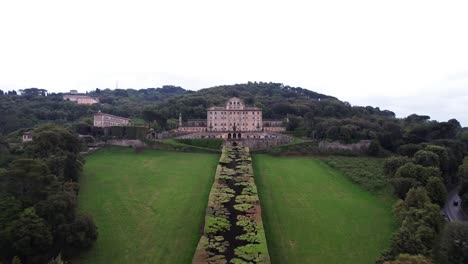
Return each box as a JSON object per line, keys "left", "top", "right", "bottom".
{"left": 0, "top": 86, "right": 188, "bottom": 135}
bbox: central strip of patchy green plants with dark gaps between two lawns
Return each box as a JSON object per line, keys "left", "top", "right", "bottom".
{"left": 192, "top": 147, "right": 270, "bottom": 264}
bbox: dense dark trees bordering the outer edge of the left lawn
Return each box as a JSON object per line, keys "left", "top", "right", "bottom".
{"left": 0, "top": 125, "right": 98, "bottom": 263}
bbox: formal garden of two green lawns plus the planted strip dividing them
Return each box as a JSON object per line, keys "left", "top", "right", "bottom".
{"left": 74, "top": 147, "right": 396, "bottom": 263}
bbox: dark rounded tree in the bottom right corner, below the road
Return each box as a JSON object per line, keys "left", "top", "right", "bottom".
{"left": 436, "top": 222, "right": 468, "bottom": 264}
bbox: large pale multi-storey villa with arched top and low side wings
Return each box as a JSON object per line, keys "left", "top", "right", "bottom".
{"left": 178, "top": 97, "right": 286, "bottom": 133}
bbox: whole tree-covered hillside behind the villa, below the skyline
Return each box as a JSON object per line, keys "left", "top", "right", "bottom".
{"left": 0, "top": 82, "right": 468, "bottom": 157}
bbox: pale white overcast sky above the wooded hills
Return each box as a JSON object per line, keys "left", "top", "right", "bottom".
{"left": 0, "top": 0, "right": 468, "bottom": 126}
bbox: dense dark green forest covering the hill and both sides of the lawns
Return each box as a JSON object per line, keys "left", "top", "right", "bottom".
{"left": 0, "top": 82, "right": 468, "bottom": 263}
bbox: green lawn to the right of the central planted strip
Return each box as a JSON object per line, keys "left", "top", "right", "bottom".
{"left": 253, "top": 155, "right": 395, "bottom": 264}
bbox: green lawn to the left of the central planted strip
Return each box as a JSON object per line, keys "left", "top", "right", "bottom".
{"left": 74, "top": 148, "right": 219, "bottom": 264}
